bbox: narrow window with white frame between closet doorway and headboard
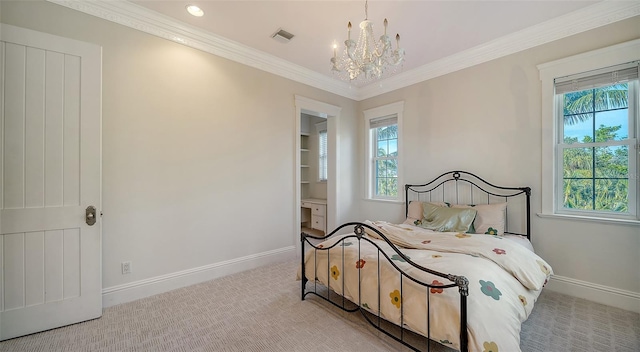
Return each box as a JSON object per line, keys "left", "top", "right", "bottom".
{"left": 365, "top": 102, "right": 404, "bottom": 201}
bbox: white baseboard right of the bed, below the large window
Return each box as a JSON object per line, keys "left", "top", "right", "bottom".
{"left": 545, "top": 275, "right": 640, "bottom": 313}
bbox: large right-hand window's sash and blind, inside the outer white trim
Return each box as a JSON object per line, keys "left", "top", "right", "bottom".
{"left": 555, "top": 63, "right": 638, "bottom": 217}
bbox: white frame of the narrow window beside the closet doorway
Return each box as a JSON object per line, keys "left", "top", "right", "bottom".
{"left": 364, "top": 101, "right": 404, "bottom": 202}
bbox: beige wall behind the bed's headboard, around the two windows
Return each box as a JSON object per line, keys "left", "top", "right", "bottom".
{"left": 358, "top": 17, "right": 640, "bottom": 300}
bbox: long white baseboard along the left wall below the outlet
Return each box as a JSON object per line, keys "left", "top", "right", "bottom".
{"left": 102, "top": 246, "right": 296, "bottom": 308}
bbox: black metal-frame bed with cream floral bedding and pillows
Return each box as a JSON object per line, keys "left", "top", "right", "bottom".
{"left": 298, "top": 171, "right": 553, "bottom": 352}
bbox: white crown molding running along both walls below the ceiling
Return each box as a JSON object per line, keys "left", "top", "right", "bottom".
{"left": 47, "top": 0, "right": 640, "bottom": 101}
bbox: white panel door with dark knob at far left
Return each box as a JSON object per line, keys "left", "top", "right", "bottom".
{"left": 0, "top": 24, "right": 102, "bottom": 340}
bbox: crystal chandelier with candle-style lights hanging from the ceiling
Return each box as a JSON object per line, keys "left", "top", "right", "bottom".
{"left": 331, "top": 1, "right": 404, "bottom": 82}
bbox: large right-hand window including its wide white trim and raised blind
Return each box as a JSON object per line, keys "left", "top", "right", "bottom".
{"left": 539, "top": 41, "right": 640, "bottom": 222}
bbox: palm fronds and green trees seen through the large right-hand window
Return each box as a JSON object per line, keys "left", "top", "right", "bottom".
{"left": 562, "top": 84, "right": 629, "bottom": 213}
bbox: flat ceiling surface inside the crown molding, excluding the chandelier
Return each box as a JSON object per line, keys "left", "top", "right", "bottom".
{"left": 133, "top": 0, "right": 596, "bottom": 76}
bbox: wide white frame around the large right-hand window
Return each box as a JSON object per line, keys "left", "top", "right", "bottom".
{"left": 538, "top": 39, "right": 640, "bottom": 224}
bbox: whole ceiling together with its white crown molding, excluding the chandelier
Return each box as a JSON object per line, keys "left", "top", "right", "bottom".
{"left": 47, "top": 0, "right": 640, "bottom": 100}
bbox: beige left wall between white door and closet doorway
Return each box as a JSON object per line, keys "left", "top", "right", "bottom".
{"left": 0, "top": 1, "right": 357, "bottom": 294}
